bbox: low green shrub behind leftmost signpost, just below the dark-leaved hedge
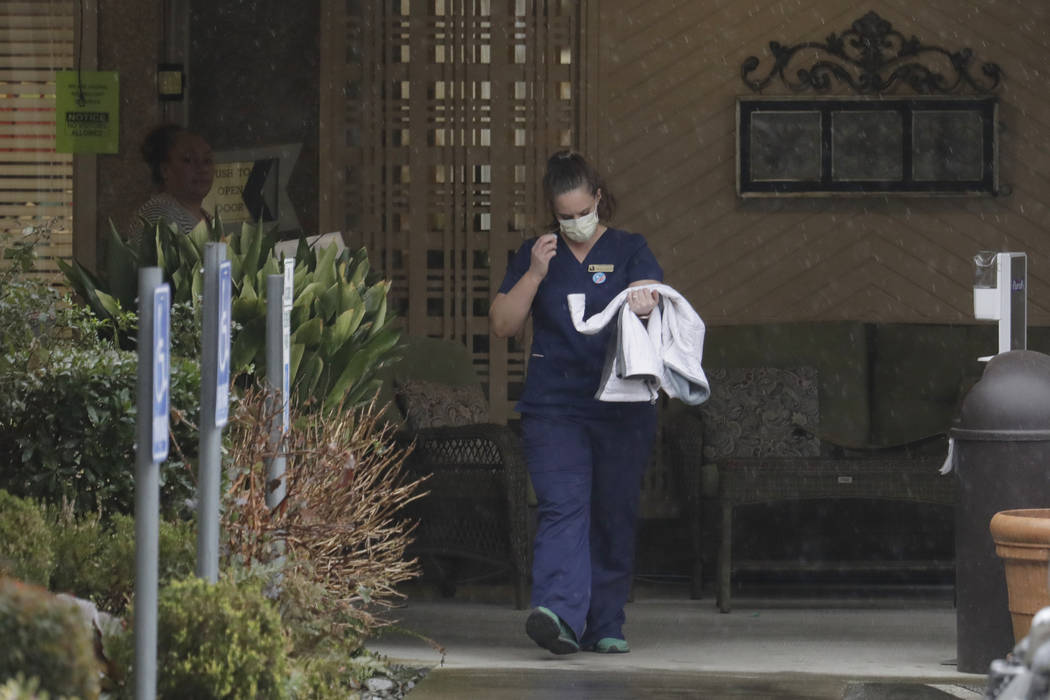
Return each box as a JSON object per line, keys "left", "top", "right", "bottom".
{"left": 51, "top": 509, "right": 196, "bottom": 614}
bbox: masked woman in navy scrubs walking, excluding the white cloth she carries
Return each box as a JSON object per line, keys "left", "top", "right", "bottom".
{"left": 489, "top": 151, "right": 664, "bottom": 654}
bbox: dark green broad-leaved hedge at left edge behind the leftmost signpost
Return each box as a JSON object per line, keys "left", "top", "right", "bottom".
{"left": 0, "top": 345, "right": 201, "bottom": 513}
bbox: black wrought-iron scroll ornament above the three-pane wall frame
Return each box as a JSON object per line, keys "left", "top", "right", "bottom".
{"left": 740, "top": 12, "right": 1003, "bottom": 94}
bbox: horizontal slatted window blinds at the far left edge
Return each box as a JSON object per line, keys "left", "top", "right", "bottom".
{"left": 0, "top": 0, "right": 74, "bottom": 279}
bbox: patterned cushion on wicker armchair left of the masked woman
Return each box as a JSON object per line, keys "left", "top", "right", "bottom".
{"left": 395, "top": 379, "right": 488, "bottom": 432}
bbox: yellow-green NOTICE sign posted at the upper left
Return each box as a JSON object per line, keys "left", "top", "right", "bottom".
{"left": 55, "top": 70, "right": 121, "bottom": 153}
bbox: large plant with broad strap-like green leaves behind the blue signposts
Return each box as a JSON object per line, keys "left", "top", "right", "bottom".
{"left": 59, "top": 217, "right": 400, "bottom": 405}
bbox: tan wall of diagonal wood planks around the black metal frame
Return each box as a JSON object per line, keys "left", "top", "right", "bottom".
{"left": 586, "top": 0, "right": 1050, "bottom": 325}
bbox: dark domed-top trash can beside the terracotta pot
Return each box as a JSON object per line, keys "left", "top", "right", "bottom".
{"left": 951, "top": 351, "right": 1050, "bottom": 674}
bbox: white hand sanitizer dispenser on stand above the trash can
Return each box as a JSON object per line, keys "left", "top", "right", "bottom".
{"left": 973, "top": 251, "right": 1028, "bottom": 360}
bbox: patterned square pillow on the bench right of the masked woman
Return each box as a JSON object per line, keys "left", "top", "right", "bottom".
{"left": 700, "top": 367, "right": 820, "bottom": 462}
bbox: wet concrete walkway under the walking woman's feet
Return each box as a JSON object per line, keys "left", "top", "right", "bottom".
{"left": 370, "top": 588, "right": 986, "bottom": 700}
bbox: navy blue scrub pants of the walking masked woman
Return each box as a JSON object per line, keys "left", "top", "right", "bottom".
{"left": 522, "top": 404, "right": 656, "bottom": 646}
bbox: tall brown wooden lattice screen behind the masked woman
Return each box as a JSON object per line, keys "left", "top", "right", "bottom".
{"left": 320, "top": 0, "right": 580, "bottom": 421}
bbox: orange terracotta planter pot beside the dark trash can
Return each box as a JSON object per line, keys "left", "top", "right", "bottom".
{"left": 991, "top": 508, "right": 1050, "bottom": 642}
